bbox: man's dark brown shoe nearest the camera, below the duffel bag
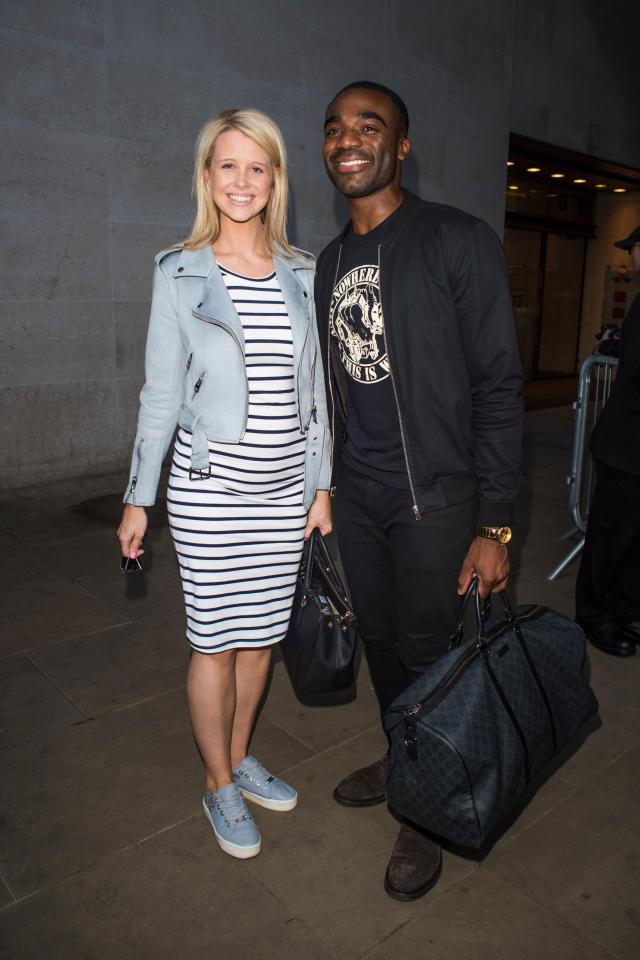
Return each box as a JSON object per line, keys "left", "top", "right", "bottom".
{"left": 384, "top": 823, "right": 442, "bottom": 900}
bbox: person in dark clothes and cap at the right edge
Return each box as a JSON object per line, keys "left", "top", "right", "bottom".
{"left": 576, "top": 226, "right": 640, "bottom": 657}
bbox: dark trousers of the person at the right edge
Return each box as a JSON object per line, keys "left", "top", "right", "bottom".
{"left": 576, "top": 460, "right": 640, "bottom": 624}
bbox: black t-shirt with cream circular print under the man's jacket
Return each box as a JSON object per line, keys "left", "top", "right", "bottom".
{"left": 330, "top": 205, "right": 409, "bottom": 487}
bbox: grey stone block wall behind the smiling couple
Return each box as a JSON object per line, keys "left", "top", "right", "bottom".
{"left": 0, "top": 0, "right": 640, "bottom": 486}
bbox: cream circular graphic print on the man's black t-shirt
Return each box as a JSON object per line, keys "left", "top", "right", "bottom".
{"left": 329, "top": 264, "right": 389, "bottom": 383}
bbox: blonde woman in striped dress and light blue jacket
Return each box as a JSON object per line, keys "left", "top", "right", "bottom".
{"left": 118, "top": 109, "right": 331, "bottom": 858}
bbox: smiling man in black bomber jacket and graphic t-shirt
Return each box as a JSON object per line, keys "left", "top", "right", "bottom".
{"left": 316, "top": 81, "right": 522, "bottom": 900}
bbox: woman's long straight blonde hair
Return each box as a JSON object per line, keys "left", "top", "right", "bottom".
{"left": 183, "top": 108, "right": 305, "bottom": 260}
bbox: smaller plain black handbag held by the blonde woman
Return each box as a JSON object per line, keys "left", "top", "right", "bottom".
{"left": 280, "top": 529, "right": 357, "bottom": 700}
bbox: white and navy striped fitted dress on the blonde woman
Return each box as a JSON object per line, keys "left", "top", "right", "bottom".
{"left": 167, "top": 268, "right": 306, "bottom": 653}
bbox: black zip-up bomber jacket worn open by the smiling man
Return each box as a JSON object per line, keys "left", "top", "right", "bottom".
{"left": 315, "top": 191, "right": 523, "bottom": 526}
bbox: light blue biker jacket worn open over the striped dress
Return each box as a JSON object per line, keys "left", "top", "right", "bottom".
{"left": 124, "top": 246, "right": 331, "bottom": 509}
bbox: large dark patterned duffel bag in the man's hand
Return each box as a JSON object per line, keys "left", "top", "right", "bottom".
{"left": 385, "top": 580, "right": 598, "bottom": 847}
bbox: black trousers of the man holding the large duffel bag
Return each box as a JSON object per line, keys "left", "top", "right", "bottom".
{"left": 333, "top": 464, "right": 477, "bottom": 714}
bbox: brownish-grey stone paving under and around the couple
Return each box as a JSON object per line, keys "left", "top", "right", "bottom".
{"left": 0, "top": 410, "right": 640, "bottom": 960}
